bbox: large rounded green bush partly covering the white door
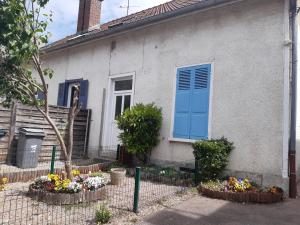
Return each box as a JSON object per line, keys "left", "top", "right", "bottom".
{"left": 117, "top": 104, "right": 162, "bottom": 160}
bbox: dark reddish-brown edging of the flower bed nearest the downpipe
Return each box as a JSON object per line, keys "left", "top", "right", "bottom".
{"left": 199, "top": 187, "right": 283, "bottom": 204}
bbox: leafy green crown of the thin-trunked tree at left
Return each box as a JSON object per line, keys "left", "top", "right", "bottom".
{"left": 0, "top": 0, "right": 53, "bottom": 106}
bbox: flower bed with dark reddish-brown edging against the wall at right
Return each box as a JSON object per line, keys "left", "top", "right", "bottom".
{"left": 199, "top": 177, "right": 283, "bottom": 203}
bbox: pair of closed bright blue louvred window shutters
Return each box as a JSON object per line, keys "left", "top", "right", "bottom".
{"left": 173, "top": 64, "right": 211, "bottom": 140}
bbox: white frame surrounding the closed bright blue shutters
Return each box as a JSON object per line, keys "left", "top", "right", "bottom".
{"left": 168, "top": 62, "right": 215, "bottom": 143}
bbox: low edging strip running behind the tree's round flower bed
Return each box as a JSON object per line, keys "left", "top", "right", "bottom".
{"left": 0, "top": 162, "right": 112, "bottom": 183}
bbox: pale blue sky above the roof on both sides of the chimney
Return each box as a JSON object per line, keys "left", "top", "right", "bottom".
{"left": 46, "top": 0, "right": 170, "bottom": 42}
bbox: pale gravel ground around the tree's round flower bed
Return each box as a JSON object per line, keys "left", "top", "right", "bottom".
{"left": 0, "top": 174, "right": 189, "bottom": 225}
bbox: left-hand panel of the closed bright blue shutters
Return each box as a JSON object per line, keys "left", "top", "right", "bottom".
{"left": 173, "top": 68, "right": 192, "bottom": 138}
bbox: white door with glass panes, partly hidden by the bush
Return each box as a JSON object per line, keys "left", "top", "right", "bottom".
{"left": 109, "top": 79, "right": 133, "bottom": 146}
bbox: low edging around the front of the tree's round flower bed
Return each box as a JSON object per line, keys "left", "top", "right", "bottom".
{"left": 28, "top": 186, "right": 106, "bottom": 205}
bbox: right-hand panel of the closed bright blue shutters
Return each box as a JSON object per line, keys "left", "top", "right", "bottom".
{"left": 190, "top": 65, "right": 211, "bottom": 140}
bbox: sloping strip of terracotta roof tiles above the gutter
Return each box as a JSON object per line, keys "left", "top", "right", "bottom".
{"left": 45, "top": 0, "right": 206, "bottom": 49}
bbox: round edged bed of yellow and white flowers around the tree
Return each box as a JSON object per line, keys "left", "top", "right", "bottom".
{"left": 29, "top": 170, "right": 107, "bottom": 205}
